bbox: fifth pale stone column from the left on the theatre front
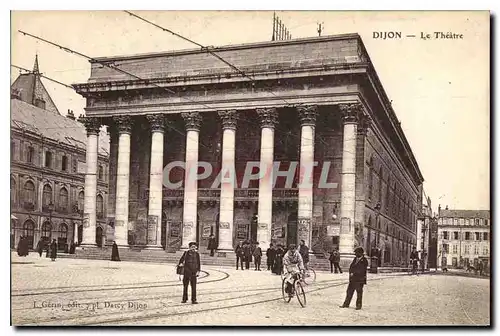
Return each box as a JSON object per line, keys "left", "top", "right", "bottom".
{"left": 219, "top": 110, "right": 237, "bottom": 251}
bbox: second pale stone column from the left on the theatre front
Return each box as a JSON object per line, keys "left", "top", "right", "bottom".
{"left": 114, "top": 116, "right": 132, "bottom": 246}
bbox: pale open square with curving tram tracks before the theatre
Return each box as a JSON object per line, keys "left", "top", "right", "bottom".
{"left": 11, "top": 253, "right": 490, "bottom": 326}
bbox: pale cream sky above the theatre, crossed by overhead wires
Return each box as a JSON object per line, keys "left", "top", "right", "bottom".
{"left": 11, "top": 11, "right": 490, "bottom": 211}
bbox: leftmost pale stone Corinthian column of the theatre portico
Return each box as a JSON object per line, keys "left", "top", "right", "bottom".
{"left": 81, "top": 117, "right": 100, "bottom": 246}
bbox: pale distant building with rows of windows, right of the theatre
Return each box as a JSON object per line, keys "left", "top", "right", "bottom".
{"left": 438, "top": 208, "right": 491, "bottom": 268}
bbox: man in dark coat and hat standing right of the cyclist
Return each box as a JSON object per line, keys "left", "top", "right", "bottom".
{"left": 340, "top": 247, "right": 368, "bottom": 310}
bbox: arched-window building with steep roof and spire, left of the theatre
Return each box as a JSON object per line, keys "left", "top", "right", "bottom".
{"left": 10, "top": 59, "right": 109, "bottom": 250}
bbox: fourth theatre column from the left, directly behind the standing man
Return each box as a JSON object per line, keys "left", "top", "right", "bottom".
{"left": 181, "top": 112, "right": 201, "bottom": 249}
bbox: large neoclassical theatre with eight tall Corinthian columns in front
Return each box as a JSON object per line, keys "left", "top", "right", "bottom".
{"left": 74, "top": 34, "right": 423, "bottom": 264}
